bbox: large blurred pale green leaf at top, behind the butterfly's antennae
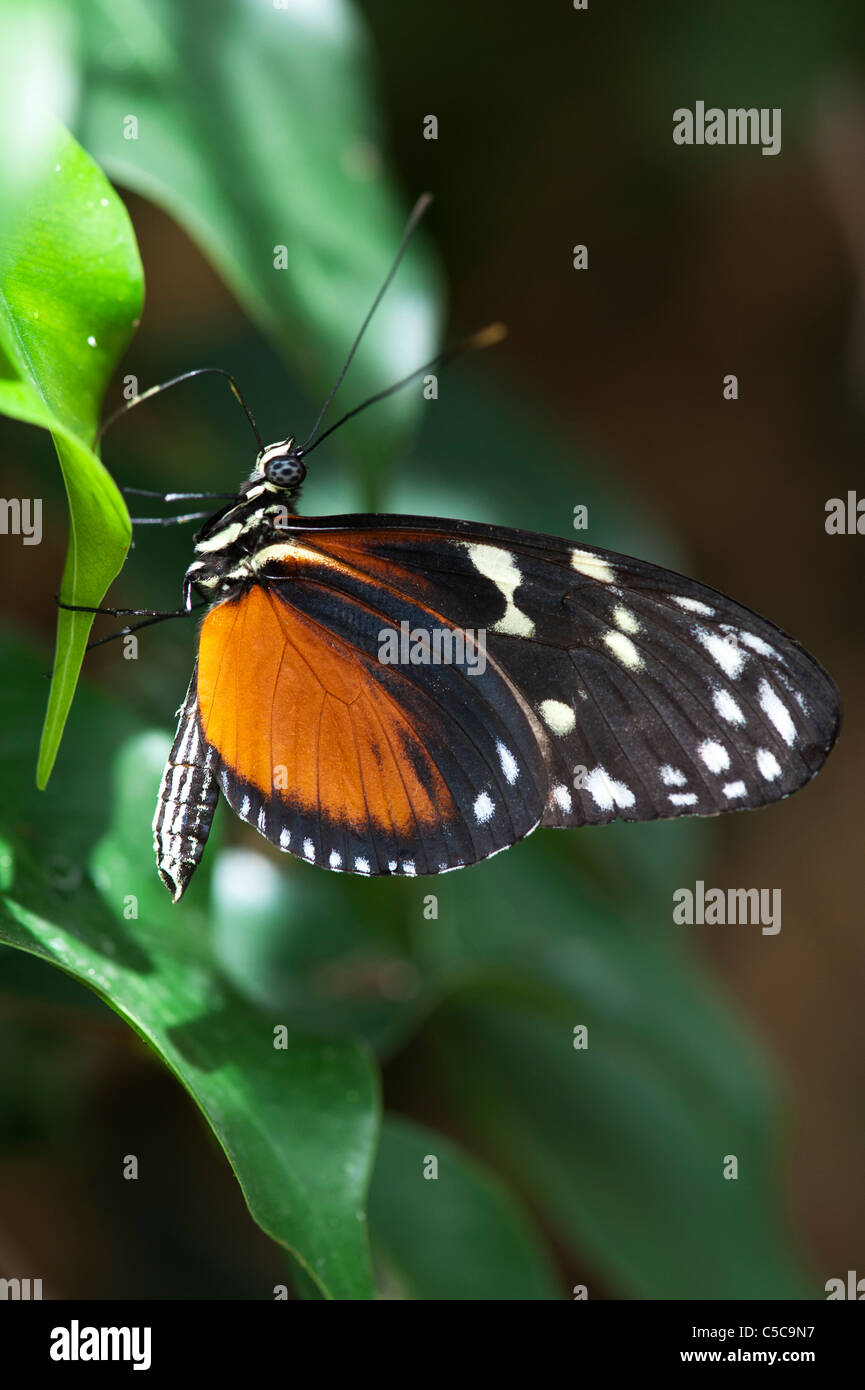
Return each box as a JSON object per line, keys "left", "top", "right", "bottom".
{"left": 78, "top": 0, "right": 437, "bottom": 497}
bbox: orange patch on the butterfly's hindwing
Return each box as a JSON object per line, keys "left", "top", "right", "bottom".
{"left": 197, "top": 584, "right": 456, "bottom": 833}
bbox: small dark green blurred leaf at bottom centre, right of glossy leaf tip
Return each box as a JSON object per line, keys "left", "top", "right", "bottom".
{"left": 370, "top": 1115, "right": 562, "bottom": 1301}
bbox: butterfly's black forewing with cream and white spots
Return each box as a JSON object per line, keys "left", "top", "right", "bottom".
{"left": 268, "top": 517, "right": 840, "bottom": 826}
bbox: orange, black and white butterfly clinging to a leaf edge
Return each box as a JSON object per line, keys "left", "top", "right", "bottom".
{"left": 86, "top": 209, "right": 840, "bottom": 902}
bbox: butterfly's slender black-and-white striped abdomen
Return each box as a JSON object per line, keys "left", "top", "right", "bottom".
{"left": 153, "top": 671, "right": 220, "bottom": 902}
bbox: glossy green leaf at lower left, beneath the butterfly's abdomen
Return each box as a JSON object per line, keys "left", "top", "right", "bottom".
{"left": 0, "top": 648, "right": 378, "bottom": 1298}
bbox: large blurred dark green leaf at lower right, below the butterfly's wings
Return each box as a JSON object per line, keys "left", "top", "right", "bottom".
{"left": 427, "top": 831, "right": 814, "bottom": 1298}
